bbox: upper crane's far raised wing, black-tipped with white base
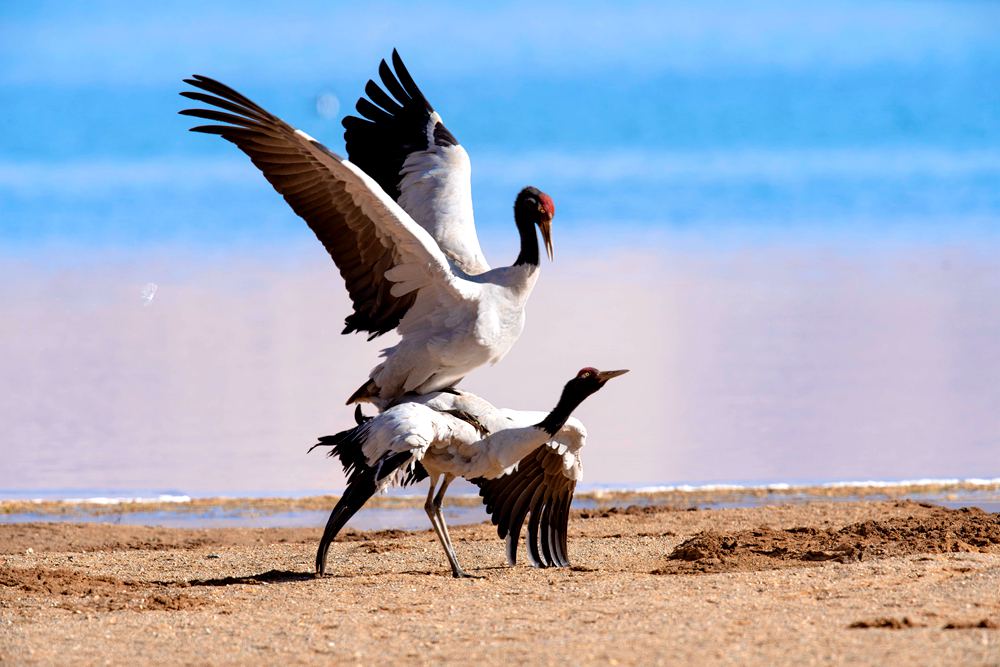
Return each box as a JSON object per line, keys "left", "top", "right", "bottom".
{"left": 343, "top": 49, "right": 490, "bottom": 275}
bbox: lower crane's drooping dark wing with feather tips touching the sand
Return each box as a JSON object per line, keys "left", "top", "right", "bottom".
{"left": 472, "top": 441, "right": 578, "bottom": 567}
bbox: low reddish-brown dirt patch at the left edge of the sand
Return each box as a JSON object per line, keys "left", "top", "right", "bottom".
{"left": 0, "top": 567, "right": 204, "bottom": 611}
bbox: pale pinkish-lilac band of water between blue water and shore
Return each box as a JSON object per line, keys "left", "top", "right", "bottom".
{"left": 0, "top": 240, "right": 1000, "bottom": 495}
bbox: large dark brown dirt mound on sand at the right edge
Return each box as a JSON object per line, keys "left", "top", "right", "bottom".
{"left": 653, "top": 507, "right": 1000, "bottom": 574}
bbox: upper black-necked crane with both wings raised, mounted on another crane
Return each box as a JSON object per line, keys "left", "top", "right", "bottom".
{"left": 181, "top": 51, "right": 555, "bottom": 408}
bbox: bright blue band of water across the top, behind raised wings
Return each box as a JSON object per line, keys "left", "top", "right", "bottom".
{"left": 0, "top": 2, "right": 1000, "bottom": 252}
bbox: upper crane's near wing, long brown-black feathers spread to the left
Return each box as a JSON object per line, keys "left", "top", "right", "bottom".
{"left": 180, "top": 75, "right": 470, "bottom": 340}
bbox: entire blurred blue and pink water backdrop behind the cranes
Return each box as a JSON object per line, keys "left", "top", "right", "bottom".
{"left": 0, "top": 0, "right": 1000, "bottom": 497}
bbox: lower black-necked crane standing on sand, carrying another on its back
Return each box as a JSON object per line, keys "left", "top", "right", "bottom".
{"left": 314, "top": 368, "right": 627, "bottom": 577}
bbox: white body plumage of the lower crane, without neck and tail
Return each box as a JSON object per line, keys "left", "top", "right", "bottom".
{"left": 362, "top": 392, "right": 587, "bottom": 489}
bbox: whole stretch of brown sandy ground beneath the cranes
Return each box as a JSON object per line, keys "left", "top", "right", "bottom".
{"left": 0, "top": 501, "right": 1000, "bottom": 665}
